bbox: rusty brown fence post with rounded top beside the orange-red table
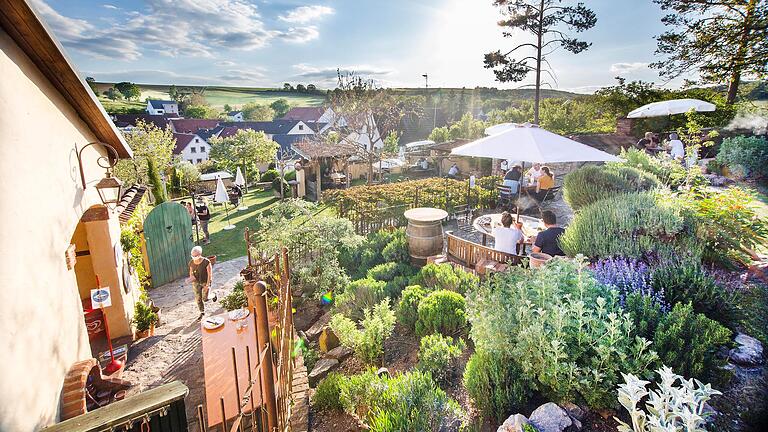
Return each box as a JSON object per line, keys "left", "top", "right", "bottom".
{"left": 253, "top": 281, "right": 278, "bottom": 432}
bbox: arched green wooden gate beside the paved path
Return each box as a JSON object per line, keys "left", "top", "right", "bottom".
{"left": 144, "top": 202, "right": 194, "bottom": 287}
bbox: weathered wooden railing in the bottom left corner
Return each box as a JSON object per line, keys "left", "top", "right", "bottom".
{"left": 43, "top": 381, "right": 189, "bottom": 432}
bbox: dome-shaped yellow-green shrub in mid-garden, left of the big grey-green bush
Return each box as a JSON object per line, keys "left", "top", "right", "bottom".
{"left": 416, "top": 290, "right": 467, "bottom": 336}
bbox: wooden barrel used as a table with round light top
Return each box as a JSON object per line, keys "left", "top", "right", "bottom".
{"left": 403, "top": 207, "right": 448, "bottom": 265}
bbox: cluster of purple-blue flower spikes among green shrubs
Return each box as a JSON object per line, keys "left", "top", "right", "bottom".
{"left": 592, "top": 258, "right": 669, "bottom": 312}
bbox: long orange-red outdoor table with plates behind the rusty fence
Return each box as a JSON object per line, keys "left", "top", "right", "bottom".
{"left": 200, "top": 312, "right": 261, "bottom": 427}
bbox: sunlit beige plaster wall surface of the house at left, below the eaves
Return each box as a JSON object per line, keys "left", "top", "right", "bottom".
{"left": 0, "top": 30, "right": 130, "bottom": 432}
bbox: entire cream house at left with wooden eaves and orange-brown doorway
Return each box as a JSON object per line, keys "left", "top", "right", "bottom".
{"left": 0, "top": 0, "right": 140, "bottom": 432}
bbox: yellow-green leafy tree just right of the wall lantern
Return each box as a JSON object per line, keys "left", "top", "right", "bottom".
{"left": 115, "top": 120, "right": 176, "bottom": 185}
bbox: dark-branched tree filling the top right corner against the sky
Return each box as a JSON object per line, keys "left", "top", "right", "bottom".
{"left": 651, "top": 0, "right": 768, "bottom": 104}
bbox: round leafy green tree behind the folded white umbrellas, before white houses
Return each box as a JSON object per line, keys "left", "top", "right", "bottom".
{"left": 210, "top": 129, "right": 279, "bottom": 181}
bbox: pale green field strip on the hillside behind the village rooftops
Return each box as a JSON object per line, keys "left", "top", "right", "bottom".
{"left": 97, "top": 83, "right": 325, "bottom": 111}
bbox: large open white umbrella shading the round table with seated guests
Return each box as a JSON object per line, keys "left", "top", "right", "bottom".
{"left": 451, "top": 123, "right": 621, "bottom": 219}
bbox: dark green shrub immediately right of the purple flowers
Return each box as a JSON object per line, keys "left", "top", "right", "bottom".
{"left": 651, "top": 261, "right": 740, "bottom": 326}
